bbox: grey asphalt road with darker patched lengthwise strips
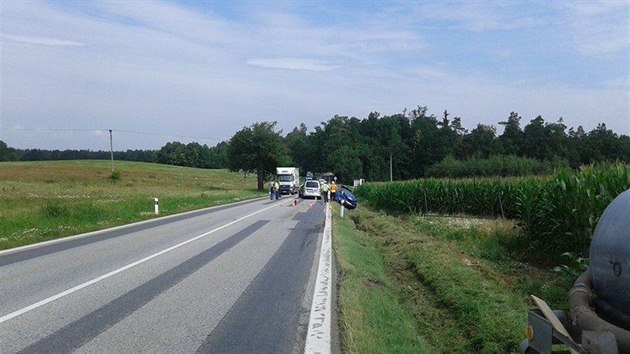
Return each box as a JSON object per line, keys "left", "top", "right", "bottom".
{"left": 0, "top": 197, "right": 325, "bottom": 353}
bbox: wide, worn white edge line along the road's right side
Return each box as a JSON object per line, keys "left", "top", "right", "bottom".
{"left": 304, "top": 204, "right": 333, "bottom": 354}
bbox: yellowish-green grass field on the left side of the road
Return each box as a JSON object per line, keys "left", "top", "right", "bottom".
{"left": 0, "top": 161, "right": 264, "bottom": 249}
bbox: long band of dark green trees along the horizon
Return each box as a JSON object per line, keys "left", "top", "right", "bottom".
{"left": 0, "top": 106, "right": 630, "bottom": 188}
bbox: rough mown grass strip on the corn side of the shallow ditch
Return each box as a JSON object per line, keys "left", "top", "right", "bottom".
{"left": 360, "top": 209, "right": 527, "bottom": 353}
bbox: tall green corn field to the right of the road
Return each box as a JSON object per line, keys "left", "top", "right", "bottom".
{"left": 355, "top": 163, "right": 630, "bottom": 254}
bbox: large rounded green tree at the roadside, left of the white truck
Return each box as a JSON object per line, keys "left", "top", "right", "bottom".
{"left": 226, "top": 122, "right": 291, "bottom": 191}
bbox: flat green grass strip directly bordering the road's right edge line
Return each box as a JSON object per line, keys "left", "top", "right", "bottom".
{"left": 333, "top": 203, "right": 427, "bottom": 353}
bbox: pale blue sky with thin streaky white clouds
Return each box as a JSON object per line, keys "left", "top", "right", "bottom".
{"left": 0, "top": 0, "right": 630, "bottom": 151}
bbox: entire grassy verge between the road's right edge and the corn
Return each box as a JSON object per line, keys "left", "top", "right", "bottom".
{"left": 334, "top": 208, "right": 569, "bottom": 353}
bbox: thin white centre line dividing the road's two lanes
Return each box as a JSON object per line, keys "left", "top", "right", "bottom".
{"left": 0, "top": 204, "right": 276, "bottom": 323}
